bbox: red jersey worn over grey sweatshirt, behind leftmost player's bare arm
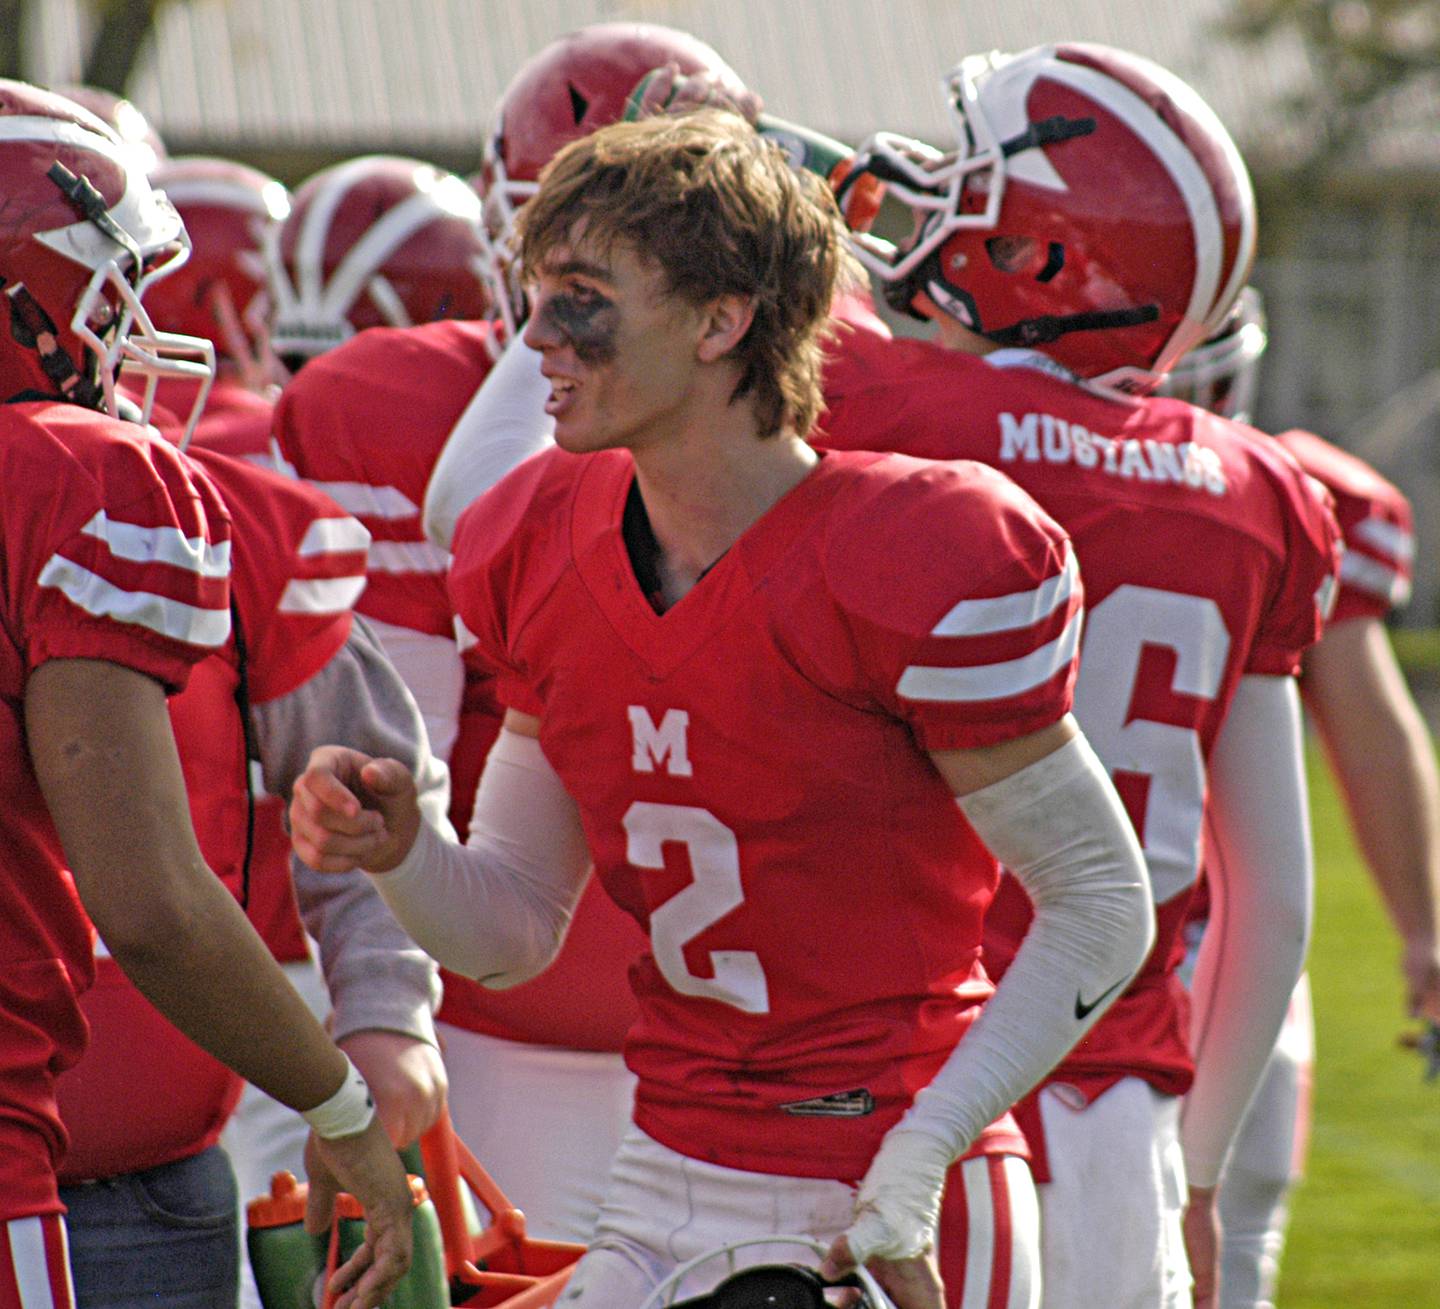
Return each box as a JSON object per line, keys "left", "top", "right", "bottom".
{"left": 59, "top": 448, "right": 367, "bottom": 1179}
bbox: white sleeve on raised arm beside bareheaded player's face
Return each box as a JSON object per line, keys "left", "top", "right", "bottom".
{"left": 423, "top": 340, "right": 554, "bottom": 550}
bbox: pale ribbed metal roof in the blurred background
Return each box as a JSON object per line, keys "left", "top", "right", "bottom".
{"left": 32, "top": 0, "right": 1308, "bottom": 168}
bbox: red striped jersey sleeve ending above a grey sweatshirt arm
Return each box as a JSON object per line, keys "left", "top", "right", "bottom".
{"left": 193, "top": 451, "right": 370, "bottom": 704}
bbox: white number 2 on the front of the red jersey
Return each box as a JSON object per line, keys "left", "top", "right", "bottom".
{"left": 625, "top": 801, "right": 770, "bottom": 1014}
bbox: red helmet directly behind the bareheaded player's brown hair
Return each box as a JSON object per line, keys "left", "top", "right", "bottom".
{"left": 478, "top": 23, "right": 753, "bottom": 340}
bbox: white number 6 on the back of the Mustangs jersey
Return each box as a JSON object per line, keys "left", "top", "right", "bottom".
{"left": 1076, "top": 586, "right": 1230, "bottom": 904}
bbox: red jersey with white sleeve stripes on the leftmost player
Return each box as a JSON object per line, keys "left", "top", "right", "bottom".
{"left": 0, "top": 402, "right": 230, "bottom": 1221}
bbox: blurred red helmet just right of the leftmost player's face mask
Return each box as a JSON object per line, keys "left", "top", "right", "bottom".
{"left": 148, "top": 156, "right": 289, "bottom": 390}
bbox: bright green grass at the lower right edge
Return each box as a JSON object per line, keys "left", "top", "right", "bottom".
{"left": 1277, "top": 752, "right": 1440, "bottom": 1309}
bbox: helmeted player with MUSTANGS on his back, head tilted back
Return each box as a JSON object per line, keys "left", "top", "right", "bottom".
{"left": 821, "top": 45, "right": 1336, "bottom": 1309}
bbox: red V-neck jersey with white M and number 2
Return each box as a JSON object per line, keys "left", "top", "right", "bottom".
{"left": 452, "top": 451, "right": 1080, "bottom": 1178}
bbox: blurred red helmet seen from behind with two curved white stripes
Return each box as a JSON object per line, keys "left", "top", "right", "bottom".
{"left": 265, "top": 154, "right": 491, "bottom": 372}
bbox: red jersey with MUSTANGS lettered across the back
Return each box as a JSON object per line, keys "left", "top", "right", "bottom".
{"left": 819, "top": 334, "right": 1338, "bottom": 1097}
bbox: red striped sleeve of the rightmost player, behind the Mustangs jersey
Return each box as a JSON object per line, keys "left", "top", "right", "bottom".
{"left": 1276, "top": 431, "right": 1416, "bottom": 624}
